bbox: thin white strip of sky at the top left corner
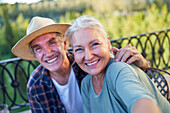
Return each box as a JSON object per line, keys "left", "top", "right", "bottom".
{"left": 0, "top": 0, "right": 40, "bottom": 4}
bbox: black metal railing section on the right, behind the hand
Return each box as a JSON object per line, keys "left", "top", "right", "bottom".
{"left": 111, "top": 29, "right": 170, "bottom": 72}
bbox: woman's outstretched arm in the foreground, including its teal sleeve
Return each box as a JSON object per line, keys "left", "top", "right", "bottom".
{"left": 107, "top": 62, "right": 164, "bottom": 113}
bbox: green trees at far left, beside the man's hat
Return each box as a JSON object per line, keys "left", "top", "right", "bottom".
{"left": 0, "top": 4, "right": 29, "bottom": 60}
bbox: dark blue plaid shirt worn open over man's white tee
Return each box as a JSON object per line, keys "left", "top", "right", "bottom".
{"left": 27, "top": 53, "right": 86, "bottom": 113}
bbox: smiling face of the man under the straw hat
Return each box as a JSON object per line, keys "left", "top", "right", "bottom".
{"left": 31, "top": 33, "right": 67, "bottom": 72}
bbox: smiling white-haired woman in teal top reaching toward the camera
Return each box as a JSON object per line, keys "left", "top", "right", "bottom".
{"left": 66, "top": 16, "right": 170, "bottom": 113}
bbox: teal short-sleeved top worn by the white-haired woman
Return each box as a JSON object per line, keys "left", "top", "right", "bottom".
{"left": 81, "top": 59, "right": 170, "bottom": 113}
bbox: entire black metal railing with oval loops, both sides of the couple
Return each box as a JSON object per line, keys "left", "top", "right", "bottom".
{"left": 0, "top": 29, "right": 170, "bottom": 110}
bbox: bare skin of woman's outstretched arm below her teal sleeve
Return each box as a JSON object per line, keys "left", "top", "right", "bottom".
{"left": 132, "top": 98, "right": 161, "bottom": 113}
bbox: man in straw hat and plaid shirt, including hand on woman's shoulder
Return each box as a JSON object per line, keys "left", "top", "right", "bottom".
{"left": 12, "top": 17, "right": 149, "bottom": 113}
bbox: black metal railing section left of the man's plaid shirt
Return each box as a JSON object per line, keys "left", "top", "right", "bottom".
{"left": 0, "top": 58, "right": 36, "bottom": 110}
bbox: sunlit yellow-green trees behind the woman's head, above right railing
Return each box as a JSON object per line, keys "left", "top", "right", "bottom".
{"left": 59, "top": 4, "right": 170, "bottom": 39}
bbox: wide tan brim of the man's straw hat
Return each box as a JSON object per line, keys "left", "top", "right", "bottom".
{"left": 12, "top": 24, "right": 70, "bottom": 61}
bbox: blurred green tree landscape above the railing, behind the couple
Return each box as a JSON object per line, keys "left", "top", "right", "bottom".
{"left": 0, "top": 0, "right": 170, "bottom": 60}
